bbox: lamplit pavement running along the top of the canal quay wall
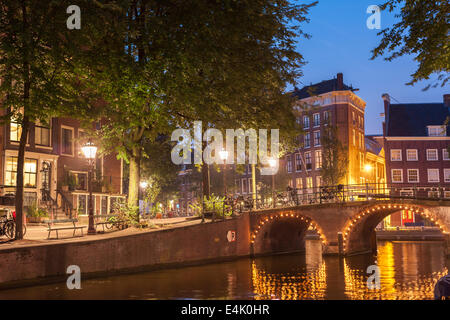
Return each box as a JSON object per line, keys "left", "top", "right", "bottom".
{"left": 0, "top": 217, "right": 201, "bottom": 250}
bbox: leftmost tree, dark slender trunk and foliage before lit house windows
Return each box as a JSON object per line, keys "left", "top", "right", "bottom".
{"left": 0, "top": 0, "right": 93, "bottom": 239}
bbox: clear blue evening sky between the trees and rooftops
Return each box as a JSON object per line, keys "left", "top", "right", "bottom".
{"left": 297, "top": 0, "right": 450, "bottom": 134}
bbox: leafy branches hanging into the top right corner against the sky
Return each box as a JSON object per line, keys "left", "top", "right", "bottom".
{"left": 372, "top": 0, "right": 450, "bottom": 90}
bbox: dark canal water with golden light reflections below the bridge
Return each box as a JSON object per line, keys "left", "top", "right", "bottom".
{"left": 0, "top": 241, "right": 450, "bottom": 300}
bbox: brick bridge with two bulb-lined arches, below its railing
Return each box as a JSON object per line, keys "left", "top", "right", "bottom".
{"left": 248, "top": 200, "right": 450, "bottom": 255}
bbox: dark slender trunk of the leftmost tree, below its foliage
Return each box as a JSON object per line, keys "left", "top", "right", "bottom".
{"left": 15, "top": 115, "right": 29, "bottom": 240}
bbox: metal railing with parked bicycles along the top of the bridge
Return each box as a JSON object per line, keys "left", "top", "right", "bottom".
{"left": 204, "top": 183, "right": 450, "bottom": 216}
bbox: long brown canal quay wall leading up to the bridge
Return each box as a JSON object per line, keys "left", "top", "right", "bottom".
{"left": 0, "top": 215, "right": 250, "bottom": 289}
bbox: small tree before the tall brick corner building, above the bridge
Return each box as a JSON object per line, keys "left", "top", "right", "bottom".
{"left": 321, "top": 125, "right": 348, "bottom": 186}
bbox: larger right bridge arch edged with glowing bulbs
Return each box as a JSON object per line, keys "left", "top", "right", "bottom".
{"left": 342, "top": 203, "right": 450, "bottom": 254}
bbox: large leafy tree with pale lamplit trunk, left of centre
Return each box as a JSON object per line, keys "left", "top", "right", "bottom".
{"left": 75, "top": 0, "right": 315, "bottom": 215}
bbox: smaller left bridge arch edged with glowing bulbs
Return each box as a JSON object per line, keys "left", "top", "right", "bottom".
{"left": 250, "top": 211, "right": 328, "bottom": 255}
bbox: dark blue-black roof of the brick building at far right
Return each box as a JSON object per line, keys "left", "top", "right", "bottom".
{"left": 386, "top": 103, "right": 450, "bottom": 137}
